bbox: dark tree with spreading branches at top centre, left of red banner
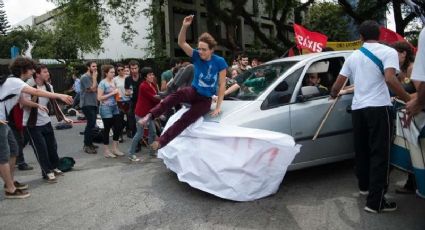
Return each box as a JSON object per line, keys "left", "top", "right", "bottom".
{"left": 205, "top": 0, "right": 314, "bottom": 56}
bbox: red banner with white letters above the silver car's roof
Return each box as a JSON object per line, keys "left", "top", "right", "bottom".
{"left": 294, "top": 24, "right": 328, "bottom": 52}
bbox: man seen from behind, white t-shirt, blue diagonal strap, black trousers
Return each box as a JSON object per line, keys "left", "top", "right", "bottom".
{"left": 331, "top": 21, "right": 410, "bottom": 213}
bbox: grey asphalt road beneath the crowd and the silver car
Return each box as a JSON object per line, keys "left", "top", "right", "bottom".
{"left": 0, "top": 120, "right": 425, "bottom": 230}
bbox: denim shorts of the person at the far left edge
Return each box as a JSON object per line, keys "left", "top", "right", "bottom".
{"left": 0, "top": 124, "right": 19, "bottom": 164}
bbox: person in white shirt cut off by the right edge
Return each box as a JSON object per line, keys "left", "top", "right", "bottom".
{"left": 406, "top": 29, "right": 425, "bottom": 116}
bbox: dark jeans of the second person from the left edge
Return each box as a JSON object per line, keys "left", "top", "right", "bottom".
{"left": 26, "top": 122, "right": 59, "bottom": 178}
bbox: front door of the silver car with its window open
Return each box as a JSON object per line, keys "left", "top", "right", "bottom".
{"left": 290, "top": 56, "right": 353, "bottom": 168}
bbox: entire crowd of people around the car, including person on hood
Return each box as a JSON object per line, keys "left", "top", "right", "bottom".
{"left": 0, "top": 15, "right": 425, "bottom": 217}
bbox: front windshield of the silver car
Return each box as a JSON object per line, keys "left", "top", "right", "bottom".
{"left": 230, "top": 61, "right": 297, "bottom": 101}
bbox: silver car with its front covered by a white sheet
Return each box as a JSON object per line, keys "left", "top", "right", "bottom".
{"left": 207, "top": 51, "right": 354, "bottom": 170}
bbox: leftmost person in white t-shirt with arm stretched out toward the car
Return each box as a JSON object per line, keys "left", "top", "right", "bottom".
{"left": 0, "top": 57, "right": 72, "bottom": 198}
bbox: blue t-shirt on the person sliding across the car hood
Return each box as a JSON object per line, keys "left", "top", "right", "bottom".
{"left": 192, "top": 49, "right": 227, "bottom": 97}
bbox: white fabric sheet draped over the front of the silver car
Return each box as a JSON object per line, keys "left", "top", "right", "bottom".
{"left": 158, "top": 109, "right": 301, "bottom": 201}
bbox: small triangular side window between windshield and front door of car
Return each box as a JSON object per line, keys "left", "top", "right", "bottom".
{"left": 261, "top": 67, "right": 304, "bottom": 110}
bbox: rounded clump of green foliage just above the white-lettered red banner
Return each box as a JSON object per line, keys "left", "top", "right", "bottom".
{"left": 305, "top": 2, "right": 350, "bottom": 41}
